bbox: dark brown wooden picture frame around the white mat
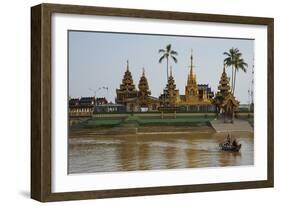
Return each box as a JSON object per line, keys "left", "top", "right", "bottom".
{"left": 31, "top": 4, "right": 274, "bottom": 202}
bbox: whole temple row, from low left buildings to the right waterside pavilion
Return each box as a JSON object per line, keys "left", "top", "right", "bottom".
{"left": 69, "top": 51, "right": 239, "bottom": 116}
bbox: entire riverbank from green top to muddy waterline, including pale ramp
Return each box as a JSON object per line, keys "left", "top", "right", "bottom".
{"left": 69, "top": 114, "right": 253, "bottom": 136}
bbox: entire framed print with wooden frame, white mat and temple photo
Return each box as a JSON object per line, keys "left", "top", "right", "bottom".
{"left": 31, "top": 4, "right": 274, "bottom": 202}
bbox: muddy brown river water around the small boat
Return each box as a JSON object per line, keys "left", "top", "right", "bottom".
{"left": 68, "top": 130, "right": 254, "bottom": 174}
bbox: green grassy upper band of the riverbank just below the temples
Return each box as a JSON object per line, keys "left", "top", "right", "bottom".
{"left": 69, "top": 112, "right": 254, "bottom": 128}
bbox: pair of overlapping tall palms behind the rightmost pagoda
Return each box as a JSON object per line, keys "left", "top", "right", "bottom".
{"left": 223, "top": 47, "right": 248, "bottom": 95}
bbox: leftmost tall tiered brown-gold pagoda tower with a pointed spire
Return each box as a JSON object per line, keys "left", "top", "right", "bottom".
{"left": 116, "top": 61, "right": 138, "bottom": 104}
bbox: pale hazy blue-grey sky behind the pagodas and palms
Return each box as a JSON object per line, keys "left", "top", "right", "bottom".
{"left": 69, "top": 31, "right": 254, "bottom": 103}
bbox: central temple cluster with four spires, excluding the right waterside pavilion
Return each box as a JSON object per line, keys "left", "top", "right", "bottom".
{"left": 116, "top": 54, "right": 216, "bottom": 112}
